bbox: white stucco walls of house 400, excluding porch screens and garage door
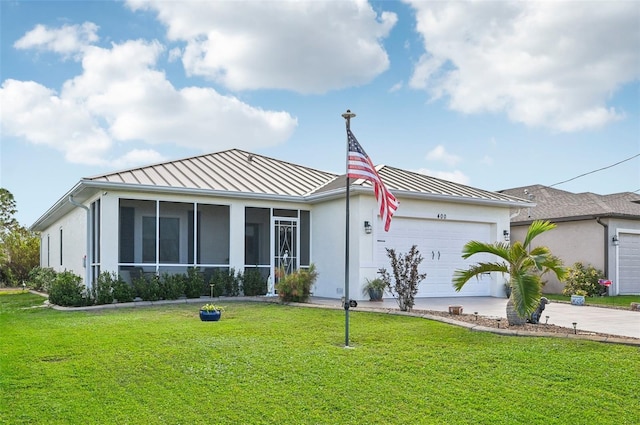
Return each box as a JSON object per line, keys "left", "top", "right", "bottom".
{"left": 41, "top": 186, "right": 509, "bottom": 299}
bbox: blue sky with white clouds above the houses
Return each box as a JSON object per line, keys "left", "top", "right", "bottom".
{"left": 0, "top": 0, "right": 640, "bottom": 226}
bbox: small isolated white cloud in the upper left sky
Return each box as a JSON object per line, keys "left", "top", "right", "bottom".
{"left": 13, "top": 22, "right": 98, "bottom": 57}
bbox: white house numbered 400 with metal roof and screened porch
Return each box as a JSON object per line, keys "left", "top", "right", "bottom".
{"left": 32, "top": 149, "right": 533, "bottom": 299}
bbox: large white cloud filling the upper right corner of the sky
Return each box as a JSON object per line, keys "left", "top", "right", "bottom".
{"left": 405, "top": 0, "right": 640, "bottom": 132}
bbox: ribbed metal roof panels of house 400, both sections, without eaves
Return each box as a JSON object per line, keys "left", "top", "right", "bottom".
{"left": 86, "top": 149, "right": 527, "bottom": 204}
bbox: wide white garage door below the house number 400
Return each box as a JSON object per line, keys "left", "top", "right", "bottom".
{"left": 376, "top": 218, "right": 492, "bottom": 297}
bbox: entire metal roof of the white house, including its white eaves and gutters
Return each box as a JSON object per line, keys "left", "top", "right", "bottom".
{"left": 31, "top": 149, "right": 534, "bottom": 230}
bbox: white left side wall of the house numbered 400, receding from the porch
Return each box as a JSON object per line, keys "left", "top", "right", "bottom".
{"left": 40, "top": 208, "right": 87, "bottom": 279}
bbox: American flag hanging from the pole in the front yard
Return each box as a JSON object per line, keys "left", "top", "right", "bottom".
{"left": 347, "top": 129, "right": 398, "bottom": 232}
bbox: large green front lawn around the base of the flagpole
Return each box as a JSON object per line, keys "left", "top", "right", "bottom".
{"left": 0, "top": 294, "right": 640, "bottom": 425}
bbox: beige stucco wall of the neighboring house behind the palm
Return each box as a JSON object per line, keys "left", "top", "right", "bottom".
{"left": 511, "top": 220, "right": 605, "bottom": 294}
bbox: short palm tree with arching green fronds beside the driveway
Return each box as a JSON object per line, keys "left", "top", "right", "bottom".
{"left": 453, "top": 220, "right": 566, "bottom": 325}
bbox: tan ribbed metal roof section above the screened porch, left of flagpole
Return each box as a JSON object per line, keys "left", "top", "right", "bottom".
{"left": 86, "top": 149, "right": 336, "bottom": 196}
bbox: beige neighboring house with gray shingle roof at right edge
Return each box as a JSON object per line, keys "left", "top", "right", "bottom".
{"left": 500, "top": 185, "right": 640, "bottom": 295}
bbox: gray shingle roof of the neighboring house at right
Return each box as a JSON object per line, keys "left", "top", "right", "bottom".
{"left": 500, "top": 185, "right": 640, "bottom": 223}
